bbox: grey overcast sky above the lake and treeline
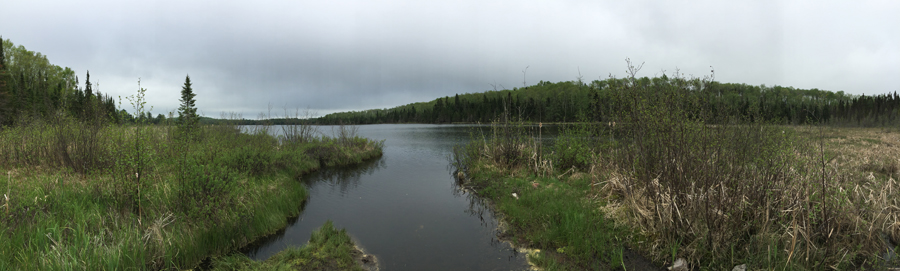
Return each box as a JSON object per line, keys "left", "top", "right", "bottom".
{"left": 0, "top": 0, "right": 900, "bottom": 118}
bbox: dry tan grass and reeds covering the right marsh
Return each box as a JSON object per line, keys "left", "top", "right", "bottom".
{"left": 591, "top": 127, "right": 900, "bottom": 269}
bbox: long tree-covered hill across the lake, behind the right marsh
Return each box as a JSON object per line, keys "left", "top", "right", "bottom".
{"left": 312, "top": 75, "right": 900, "bottom": 126}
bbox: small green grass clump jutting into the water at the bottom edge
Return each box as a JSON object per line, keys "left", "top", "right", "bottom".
{"left": 212, "top": 220, "right": 372, "bottom": 270}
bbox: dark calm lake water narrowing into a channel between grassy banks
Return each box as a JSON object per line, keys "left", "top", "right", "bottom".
{"left": 247, "top": 124, "right": 560, "bottom": 270}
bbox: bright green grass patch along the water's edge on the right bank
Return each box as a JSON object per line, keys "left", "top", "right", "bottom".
{"left": 465, "top": 163, "right": 631, "bottom": 270}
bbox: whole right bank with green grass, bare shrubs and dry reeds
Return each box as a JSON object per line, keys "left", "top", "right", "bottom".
{"left": 453, "top": 62, "right": 900, "bottom": 270}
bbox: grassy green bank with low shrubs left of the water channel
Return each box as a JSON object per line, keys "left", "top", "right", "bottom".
{"left": 0, "top": 118, "right": 382, "bottom": 270}
